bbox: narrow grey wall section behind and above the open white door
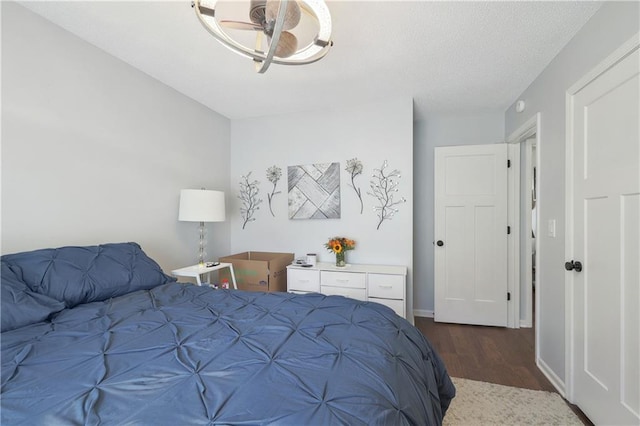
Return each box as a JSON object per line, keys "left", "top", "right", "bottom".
{"left": 413, "top": 111, "right": 504, "bottom": 316}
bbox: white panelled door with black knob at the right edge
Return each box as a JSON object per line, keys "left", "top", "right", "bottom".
{"left": 566, "top": 47, "right": 640, "bottom": 425}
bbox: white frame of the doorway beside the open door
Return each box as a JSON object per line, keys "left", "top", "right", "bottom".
{"left": 507, "top": 112, "right": 543, "bottom": 332}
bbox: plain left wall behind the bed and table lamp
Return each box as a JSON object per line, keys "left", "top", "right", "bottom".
{"left": 2, "top": 2, "right": 230, "bottom": 270}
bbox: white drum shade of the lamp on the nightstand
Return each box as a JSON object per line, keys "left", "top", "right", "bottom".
{"left": 178, "top": 189, "right": 225, "bottom": 222}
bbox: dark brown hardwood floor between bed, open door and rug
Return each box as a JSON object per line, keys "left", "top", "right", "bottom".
{"left": 415, "top": 317, "right": 592, "bottom": 425}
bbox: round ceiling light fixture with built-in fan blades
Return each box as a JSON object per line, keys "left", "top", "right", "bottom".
{"left": 192, "top": 0, "right": 333, "bottom": 73}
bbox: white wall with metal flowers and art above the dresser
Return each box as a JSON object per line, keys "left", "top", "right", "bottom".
{"left": 231, "top": 98, "right": 414, "bottom": 316}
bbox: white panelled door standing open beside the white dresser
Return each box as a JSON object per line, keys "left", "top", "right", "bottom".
{"left": 434, "top": 144, "right": 507, "bottom": 326}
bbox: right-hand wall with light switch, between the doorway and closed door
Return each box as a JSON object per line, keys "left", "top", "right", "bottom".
{"left": 505, "top": 2, "right": 640, "bottom": 382}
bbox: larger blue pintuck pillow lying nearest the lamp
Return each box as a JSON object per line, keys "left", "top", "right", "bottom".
{"left": 2, "top": 243, "right": 176, "bottom": 308}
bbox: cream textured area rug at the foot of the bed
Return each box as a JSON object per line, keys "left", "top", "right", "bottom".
{"left": 443, "top": 377, "right": 582, "bottom": 426}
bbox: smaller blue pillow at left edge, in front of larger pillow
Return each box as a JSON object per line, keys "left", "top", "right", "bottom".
{"left": 0, "top": 262, "right": 64, "bottom": 331}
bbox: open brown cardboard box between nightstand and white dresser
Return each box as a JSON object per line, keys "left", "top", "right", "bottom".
{"left": 218, "top": 251, "right": 294, "bottom": 291}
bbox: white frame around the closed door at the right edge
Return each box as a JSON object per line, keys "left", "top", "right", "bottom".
{"left": 564, "top": 33, "right": 640, "bottom": 402}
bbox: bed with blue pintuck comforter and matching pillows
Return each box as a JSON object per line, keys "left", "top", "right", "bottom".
{"left": 0, "top": 243, "right": 455, "bottom": 425}
